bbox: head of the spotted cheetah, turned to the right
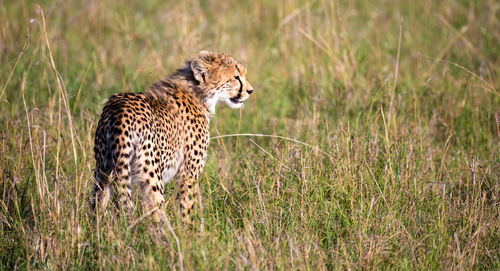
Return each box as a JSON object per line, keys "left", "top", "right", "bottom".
{"left": 190, "top": 51, "right": 253, "bottom": 113}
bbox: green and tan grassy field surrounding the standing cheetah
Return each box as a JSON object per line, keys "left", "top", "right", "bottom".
{"left": 0, "top": 0, "right": 500, "bottom": 270}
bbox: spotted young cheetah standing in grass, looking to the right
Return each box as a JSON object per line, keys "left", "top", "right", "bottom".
{"left": 93, "top": 51, "right": 253, "bottom": 224}
